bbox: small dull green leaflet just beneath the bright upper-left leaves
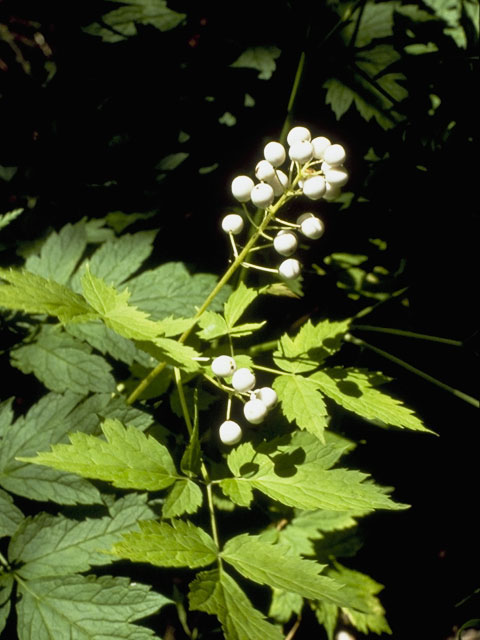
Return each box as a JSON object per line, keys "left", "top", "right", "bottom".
{"left": 65, "top": 320, "right": 138, "bottom": 364}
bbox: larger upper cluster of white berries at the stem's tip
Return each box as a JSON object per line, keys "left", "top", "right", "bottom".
{"left": 222, "top": 127, "right": 348, "bottom": 280}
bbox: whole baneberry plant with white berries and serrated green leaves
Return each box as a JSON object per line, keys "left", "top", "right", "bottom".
{"left": 0, "top": 126, "right": 436, "bottom": 640}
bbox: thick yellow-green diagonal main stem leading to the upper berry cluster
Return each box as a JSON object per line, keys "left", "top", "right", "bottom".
{"left": 127, "top": 192, "right": 293, "bottom": 404}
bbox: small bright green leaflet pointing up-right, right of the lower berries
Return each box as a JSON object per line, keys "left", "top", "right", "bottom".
{"left": 273, "top": 320, "right": 350, "bottom": 373}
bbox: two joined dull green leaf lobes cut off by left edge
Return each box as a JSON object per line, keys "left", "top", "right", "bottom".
{"left": 0, "top": 393, "right": 102, "bottom": 504}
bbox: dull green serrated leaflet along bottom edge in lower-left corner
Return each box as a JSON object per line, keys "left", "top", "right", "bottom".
{"left": 17, "top": 575, "right": 171, "bottom": 640}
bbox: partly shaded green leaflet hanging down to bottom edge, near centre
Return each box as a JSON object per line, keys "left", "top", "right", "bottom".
{"left": 188, "top": 570, "right": 283, "bottom": 640}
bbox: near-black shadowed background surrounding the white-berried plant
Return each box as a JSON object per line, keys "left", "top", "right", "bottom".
{"left": 0, "top": 0, "right": 480, "bottom": 640}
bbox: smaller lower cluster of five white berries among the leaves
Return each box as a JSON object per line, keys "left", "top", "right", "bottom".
{"left": 211, "top": 355, "right": 278, "bottom": 445}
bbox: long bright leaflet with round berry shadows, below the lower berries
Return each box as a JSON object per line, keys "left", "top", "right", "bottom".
{"left": 221, "top": 436, "right": 405, "bottom": 513}
